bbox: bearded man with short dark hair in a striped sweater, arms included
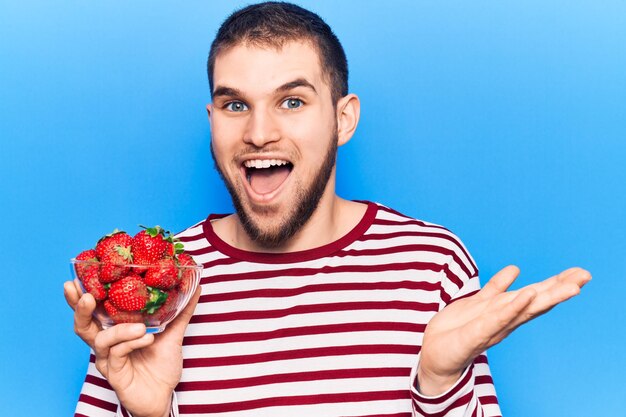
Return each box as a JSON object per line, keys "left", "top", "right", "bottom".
{"left": 65, "top": 3, "right": 590, "bottom": 417}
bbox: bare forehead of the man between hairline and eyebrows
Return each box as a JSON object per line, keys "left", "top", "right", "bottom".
{"left": 213, "top": 41, "right": 330, "bottom": 94}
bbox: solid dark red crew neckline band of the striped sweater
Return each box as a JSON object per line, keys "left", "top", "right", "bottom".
{"left": 202, "top": 201, "right": 378, "bottom": 264}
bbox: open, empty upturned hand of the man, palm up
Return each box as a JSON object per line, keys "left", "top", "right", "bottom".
{"left": 418, "top": 266, "right": 591, "bottom": 395}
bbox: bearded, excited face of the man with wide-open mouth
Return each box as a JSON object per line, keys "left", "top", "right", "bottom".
{"left": 209, "top": 42, "right": 337, "bottom": 247}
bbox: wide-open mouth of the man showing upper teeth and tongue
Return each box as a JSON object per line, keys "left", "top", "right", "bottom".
{"left": 243, "top": 159, "right": 293, "bottom": 195}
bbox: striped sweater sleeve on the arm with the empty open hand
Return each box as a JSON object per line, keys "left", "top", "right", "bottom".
{"left": 411, "top": 231, "right": 501, "bottom": 417}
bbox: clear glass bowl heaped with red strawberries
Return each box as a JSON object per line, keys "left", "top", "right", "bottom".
{"left": 70, "top": 226, "right": 202, "bottom": 333}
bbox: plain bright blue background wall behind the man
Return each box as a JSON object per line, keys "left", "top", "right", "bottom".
{"left": 0, "top": 0, "right": 626, "bottom": 416}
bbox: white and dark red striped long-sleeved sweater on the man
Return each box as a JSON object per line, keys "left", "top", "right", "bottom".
{"left": 75, "top": 203, "right": 500, "bottom": 417}
